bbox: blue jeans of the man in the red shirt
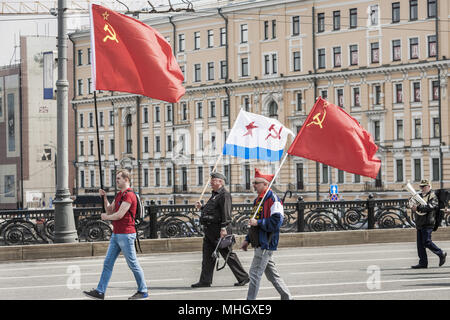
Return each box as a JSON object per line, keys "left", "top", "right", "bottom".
{"left": 97, "top": 233, "right": 147, "bottom": 293}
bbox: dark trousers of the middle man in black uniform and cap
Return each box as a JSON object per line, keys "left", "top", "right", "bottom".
{"left": 200, "top": 237, "right": 248, "bottom": 284}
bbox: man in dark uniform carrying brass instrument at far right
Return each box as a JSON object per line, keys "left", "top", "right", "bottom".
{"left": 409, "top": 180, "right": 447, "bottom": 269}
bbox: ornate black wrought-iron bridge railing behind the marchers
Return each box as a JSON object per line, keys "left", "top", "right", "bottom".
{"left": 0, "top": 192, "right": 450, "bottom": 245}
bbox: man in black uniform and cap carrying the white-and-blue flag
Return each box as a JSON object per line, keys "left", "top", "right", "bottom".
{"left": 191, "top": 172, "right": 249, "bottom": 288}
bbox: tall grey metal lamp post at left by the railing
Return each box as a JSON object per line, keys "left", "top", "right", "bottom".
{"left": 53, "top": 0, "right": 78, "bottom": 243}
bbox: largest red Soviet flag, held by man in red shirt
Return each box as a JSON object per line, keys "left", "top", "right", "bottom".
{"left": 90, "top": 4, "right": 185, "bottom": 102}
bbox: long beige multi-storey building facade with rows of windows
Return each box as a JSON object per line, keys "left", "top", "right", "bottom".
{"left": 70, "top": 0, "right": 450, "bottom": 204}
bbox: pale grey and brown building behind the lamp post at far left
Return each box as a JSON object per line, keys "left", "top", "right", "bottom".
{"left": 0, "top": 36, "right": 75, "bottom": 209}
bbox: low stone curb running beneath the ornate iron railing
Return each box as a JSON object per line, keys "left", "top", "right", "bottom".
{"left": 0, "top": 227, "right": 450, "bottom": 262}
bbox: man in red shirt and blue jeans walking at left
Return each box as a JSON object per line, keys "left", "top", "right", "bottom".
{"left": 83, "top": 170, "right": 148, "bottom": 300}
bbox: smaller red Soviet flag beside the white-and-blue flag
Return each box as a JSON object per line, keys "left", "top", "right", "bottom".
{"left": 288, "top": 97, "right": 381, "bottom": 179}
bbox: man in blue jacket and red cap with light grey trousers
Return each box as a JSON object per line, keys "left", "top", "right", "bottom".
{"left": 242, "top": 169, "right": 292, "bottom": 300}
